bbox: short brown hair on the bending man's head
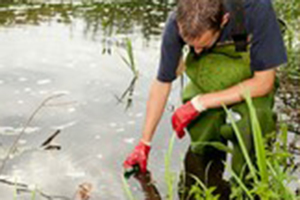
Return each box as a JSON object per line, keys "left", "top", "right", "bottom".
{"left": 176, "top": 0, "right": 224, "bottom": 40}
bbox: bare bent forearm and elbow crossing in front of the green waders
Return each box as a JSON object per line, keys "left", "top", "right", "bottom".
{"left": 193, "top": 69, "right": 275, "bottom": 109}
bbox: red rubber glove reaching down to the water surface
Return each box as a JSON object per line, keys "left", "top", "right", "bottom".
{"left": 123, "top": 141, "right": 151, "bottom": 173}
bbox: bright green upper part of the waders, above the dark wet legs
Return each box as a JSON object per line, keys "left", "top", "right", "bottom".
{"left": 183, "top": 45, "right": 275, "bottom": 177}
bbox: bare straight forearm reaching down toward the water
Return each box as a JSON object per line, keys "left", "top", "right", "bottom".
{"left": 142, "top": 79, "right": 172, "bottom": 143}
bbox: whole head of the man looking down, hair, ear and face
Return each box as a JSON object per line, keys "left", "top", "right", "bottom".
{"left": 176, "top": 0, "right": 229, "bottom": 53}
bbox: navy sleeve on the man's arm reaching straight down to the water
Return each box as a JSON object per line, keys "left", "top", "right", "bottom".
{"left": 157, "top": 12, "right": 184, "bottom": 82}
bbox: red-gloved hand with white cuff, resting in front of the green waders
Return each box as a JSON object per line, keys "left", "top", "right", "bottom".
{"left": 172, "top": 96, "right": 206, "bottom": 139}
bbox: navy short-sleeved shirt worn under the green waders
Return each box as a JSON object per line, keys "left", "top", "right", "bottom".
{"left": 157, "top": 0, "right": 287, "bottom": 82}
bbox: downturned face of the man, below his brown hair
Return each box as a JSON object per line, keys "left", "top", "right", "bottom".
{"left": 183, "top": 30, "right": 220, "bottom": 54}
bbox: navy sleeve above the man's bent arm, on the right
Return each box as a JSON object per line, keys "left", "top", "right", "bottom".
{"left": 249, "top": 0, "right": 287, "bottom": 71}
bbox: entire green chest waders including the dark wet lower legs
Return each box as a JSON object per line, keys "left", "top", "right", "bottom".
{"left": 179, "top": 45, "right": 276, "bottom": 200}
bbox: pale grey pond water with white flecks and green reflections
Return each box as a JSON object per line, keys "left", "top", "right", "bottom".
{"left": 0, "top": 1, "right": 298, "bottom": 200}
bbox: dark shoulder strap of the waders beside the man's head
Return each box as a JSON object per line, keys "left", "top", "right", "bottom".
{"left": 227, "top": 0, "right": 248, "bottom": 52}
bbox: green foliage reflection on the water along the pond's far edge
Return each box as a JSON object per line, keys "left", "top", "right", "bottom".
{"left": 0, "top": 0, "right": 174, "bottom": 39}
